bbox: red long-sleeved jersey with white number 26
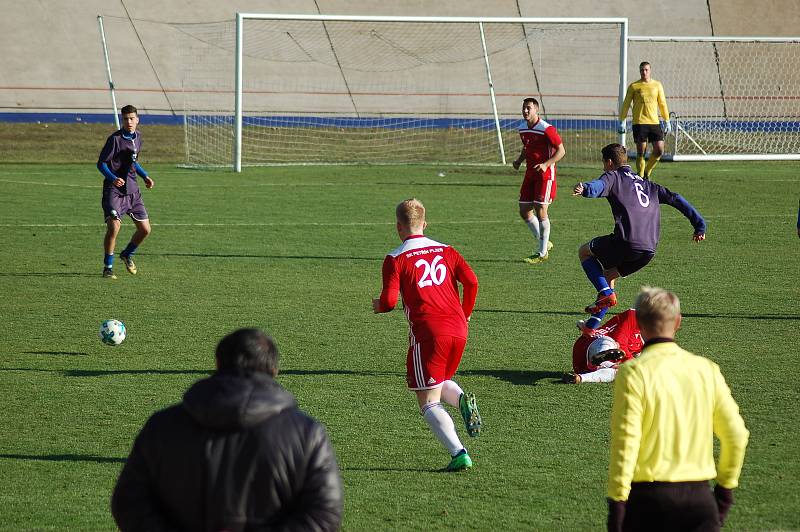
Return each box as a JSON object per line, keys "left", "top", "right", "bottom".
{"left": 379, "top": 235, "right": 478, "bottom": 341}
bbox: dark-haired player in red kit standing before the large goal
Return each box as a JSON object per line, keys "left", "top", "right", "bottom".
{"left": 512, "top": 98, "right": 566, "bottom": 264}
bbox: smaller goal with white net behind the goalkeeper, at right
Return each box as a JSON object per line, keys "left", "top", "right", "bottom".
{"left": 628, "top": 37, "right": 800, "bottom": 161}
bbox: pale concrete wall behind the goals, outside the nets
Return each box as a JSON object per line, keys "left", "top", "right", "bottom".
{"left": 0, "top": 0, "right": 800, "bottom": 117}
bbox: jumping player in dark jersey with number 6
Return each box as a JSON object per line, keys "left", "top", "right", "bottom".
{"left": 573, "top": 144, "right": 706, "bottom": 329}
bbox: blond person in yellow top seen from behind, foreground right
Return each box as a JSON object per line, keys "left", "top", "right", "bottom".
{"left": 607, "top": 287, "right": 750, "bottom": 531}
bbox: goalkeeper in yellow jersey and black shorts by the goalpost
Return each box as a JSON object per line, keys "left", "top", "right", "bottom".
{"left": 619, "top": 61, "right": 672, "bottom": 179}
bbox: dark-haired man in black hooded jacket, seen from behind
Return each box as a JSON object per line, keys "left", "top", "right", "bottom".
{"left": 111, "top": 329, "right": 343, "bottom": 532}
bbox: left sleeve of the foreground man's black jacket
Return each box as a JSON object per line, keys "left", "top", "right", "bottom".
{"left": 111, "top": 421, "right": 174, "bottom": 532}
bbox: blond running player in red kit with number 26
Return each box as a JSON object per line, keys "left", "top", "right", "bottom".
{"left": 372, "top": 198, "right": 481, "bottom": 471}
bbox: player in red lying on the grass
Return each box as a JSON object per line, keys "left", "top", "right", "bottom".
{"left": 564, "top": 309, "right": 644, "bottom": 383}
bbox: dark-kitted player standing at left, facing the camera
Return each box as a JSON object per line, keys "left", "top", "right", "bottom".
{"left": 97, "top": 105, "right": 154, "bottom": 279}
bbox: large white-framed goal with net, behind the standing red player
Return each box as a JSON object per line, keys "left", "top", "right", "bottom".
{"left": 181, "top": 15, "right": 624, "bottom": 169}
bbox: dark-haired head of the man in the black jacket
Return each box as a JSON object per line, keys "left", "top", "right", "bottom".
{"left": 216, "top": 329, "right": 279, "bottom": 376}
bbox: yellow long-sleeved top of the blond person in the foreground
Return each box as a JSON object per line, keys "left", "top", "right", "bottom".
{"left": 608, "top": 342, "right": 750, "bottom": 501}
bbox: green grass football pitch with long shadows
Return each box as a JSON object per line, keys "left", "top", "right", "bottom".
{"left": 0, "top": 153, "right": 800, "bottom": 530}
